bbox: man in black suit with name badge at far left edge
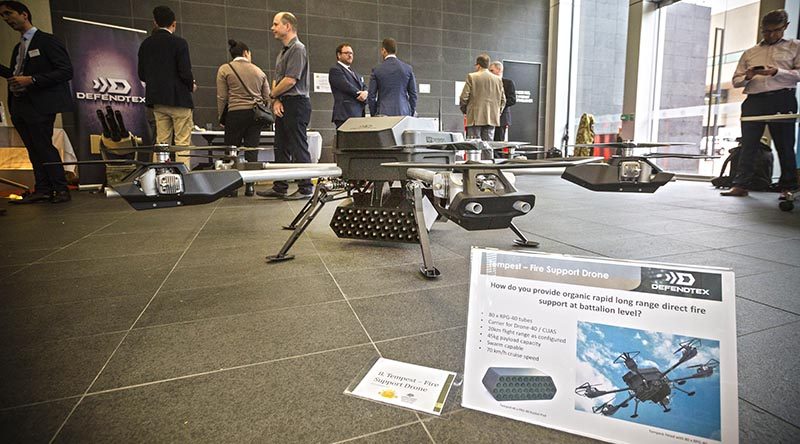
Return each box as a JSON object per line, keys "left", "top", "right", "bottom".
{"left": 0, "top": 1, "right": 73, "bottom": 204}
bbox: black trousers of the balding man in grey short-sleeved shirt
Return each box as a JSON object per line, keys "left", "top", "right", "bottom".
{"left": 272, "top": 96, "right": 314, "bottom": 194}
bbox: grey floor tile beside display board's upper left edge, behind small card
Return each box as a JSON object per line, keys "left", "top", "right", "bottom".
{"left": 350, "top": 284, "right": 469, "bottom": 341}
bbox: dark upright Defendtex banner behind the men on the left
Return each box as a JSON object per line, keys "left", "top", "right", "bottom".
{"left": 54, "top": 17, "right": 149, "bottom": 184}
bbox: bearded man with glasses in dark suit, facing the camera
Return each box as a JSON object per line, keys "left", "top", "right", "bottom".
{"left": 328, "top": 43, "right": 367, "bottom": 128}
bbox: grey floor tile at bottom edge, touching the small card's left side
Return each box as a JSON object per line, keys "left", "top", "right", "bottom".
{"left": 57, "top": 346, "right": 415, "bottom": 443}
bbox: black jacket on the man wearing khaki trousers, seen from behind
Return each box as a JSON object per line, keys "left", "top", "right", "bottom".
{"left": 139, "top": 29, "right": 194, "bottom": 108}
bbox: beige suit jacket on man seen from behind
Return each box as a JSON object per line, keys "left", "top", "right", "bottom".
{"left": 459, "top": 69, "right": 506, "bottom": 126}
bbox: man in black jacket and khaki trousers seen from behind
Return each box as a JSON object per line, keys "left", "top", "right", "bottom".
{"left": 138, "top": 6, "right": 197, "bottom": 146}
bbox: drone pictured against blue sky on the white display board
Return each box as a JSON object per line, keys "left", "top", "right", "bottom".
{"left": 575, "top": 338, "right": 719, "bottom": 418}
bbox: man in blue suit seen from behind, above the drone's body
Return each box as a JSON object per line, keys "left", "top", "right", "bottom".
{"left": 367, "top": 38, "right": 417, "bottom": 116}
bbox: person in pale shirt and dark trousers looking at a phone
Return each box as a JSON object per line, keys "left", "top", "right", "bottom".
{"left": 721, "top": 9, "right": 800, "bottom": 199}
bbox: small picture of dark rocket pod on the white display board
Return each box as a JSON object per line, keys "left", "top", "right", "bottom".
{"left": 483, "top": 367, "right": 556, "bottom": 401}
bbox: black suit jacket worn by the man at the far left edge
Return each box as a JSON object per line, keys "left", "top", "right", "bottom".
{"left": 0, "top": 30, "right": 74, "bottom": 114}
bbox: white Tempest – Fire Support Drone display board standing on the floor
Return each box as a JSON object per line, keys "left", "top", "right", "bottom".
{"left": 462, "top": 248, "right": 739, "bottom": 443}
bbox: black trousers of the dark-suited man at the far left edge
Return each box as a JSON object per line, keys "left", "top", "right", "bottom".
{"left": 9, "top": 95, "right": 67, "bottom": 194}
